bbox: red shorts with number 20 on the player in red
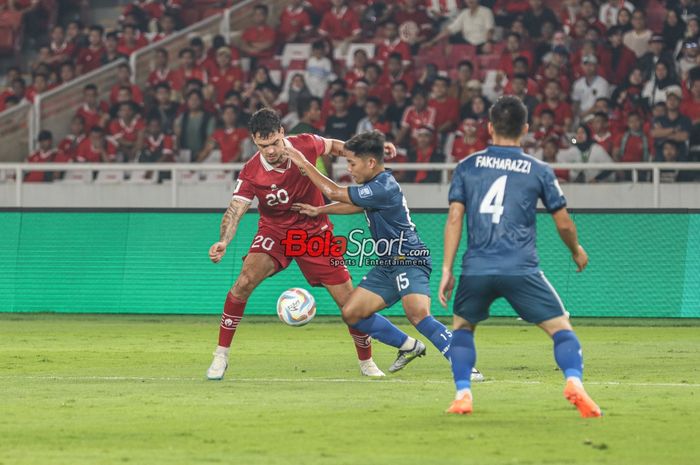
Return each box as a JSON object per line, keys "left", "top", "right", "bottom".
{"left": 248, "top": 226, "right": 350, "bottom": 286}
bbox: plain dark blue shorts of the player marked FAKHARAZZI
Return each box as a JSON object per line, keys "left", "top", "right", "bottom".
{"left": 452, "top": 271, "right": 565, "bottom": 324}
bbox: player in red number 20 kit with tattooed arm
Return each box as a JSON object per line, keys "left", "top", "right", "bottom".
{"left": 207, "top": 108, "right": 395, "bottom": 380}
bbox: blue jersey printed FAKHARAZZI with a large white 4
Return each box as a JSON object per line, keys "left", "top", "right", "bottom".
{"left": 449, "top": 146, "right": 566, "bottom": 275}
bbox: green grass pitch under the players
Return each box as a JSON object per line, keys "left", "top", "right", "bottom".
{"left": 0, "top": 314, "right": 700, "bottom": 465}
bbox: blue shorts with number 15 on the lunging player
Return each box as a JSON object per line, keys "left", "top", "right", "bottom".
{"left": 357, "top": 265, "right": 432, "bottom": 308}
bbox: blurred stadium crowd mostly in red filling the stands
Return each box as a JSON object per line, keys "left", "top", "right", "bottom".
{"left": 0, "top": 0, "right": 700, "bottom": 182}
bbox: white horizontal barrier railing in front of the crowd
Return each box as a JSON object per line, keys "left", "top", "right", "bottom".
{"left": 0, "top": 163, "right": 700, "bottom": 208}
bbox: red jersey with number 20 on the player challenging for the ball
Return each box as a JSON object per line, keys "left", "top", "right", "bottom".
{"left": 233, "top": 134, "right": 332, "bottom": 234}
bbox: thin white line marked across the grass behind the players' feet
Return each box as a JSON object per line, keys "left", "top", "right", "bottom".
{"left": 0, "top": 375, "right": 700, "bottom": 387}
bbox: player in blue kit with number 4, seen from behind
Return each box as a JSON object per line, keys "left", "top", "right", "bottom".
{"left": 438, "top": 96, "right": 601, "bottom": 417}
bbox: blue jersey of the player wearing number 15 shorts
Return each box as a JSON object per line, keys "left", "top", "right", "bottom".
{"left": 348, "top": 170, "right": 427, "bottom": 257}
